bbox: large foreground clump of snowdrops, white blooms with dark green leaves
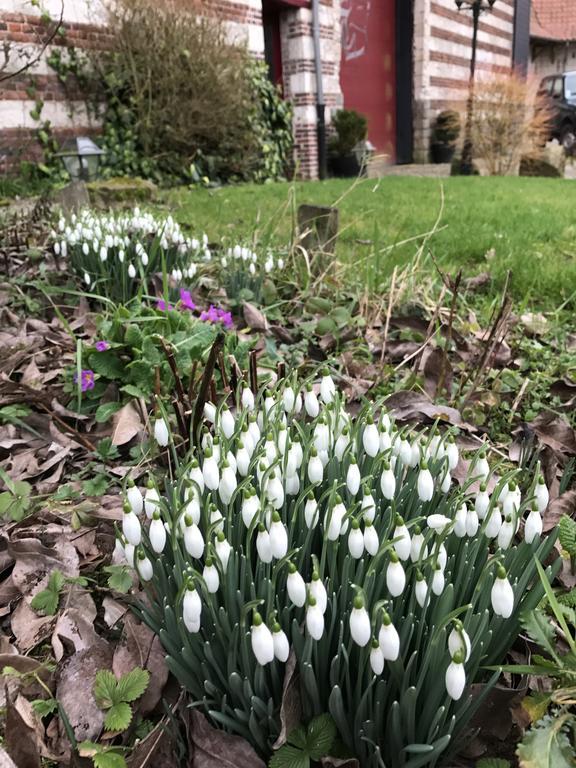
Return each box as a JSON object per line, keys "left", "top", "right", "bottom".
{"left": 117, "top": 371, "right": 554, "bottom": 768}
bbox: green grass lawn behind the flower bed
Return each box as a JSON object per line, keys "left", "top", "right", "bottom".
{"left": 166, "top": 177, "right": 576, "bottom": 309}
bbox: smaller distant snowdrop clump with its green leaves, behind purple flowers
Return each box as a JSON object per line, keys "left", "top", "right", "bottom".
{"left": 51, "top": 208, "right": 211, "bottom": 303}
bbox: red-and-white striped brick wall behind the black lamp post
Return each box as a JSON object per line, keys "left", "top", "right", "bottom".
{"left": 414, "top": 0, "right": 514, "bottom": 162}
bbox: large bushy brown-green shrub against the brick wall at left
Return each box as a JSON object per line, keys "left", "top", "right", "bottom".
{"left": 93, "top": 0, "right": 292, "bottom": 181}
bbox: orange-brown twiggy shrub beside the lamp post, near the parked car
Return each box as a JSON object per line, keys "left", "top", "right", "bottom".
{"left": 472, "top": 72, "right": 551, "bottom": 176}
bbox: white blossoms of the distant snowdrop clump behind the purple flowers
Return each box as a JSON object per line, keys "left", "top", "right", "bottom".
{"left": 51, "top": 207, "right": 210, "bottom": 287}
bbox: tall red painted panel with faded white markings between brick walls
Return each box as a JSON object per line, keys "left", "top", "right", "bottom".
{"left": 340, "top": 0, "right": 396, "bottom": 160}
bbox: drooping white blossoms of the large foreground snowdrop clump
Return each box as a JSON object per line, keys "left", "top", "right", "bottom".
{"left": 117, "top": 371, "right": 548, "bottom": 700}
